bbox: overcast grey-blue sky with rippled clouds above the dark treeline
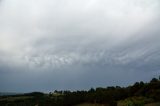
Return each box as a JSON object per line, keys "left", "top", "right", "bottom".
{"left": 0, "top": 0, "right": 160, "bottom": 92}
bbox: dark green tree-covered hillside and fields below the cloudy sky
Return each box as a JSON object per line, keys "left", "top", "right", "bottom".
{"left": 0, "top": 78, "right": 160, "bottom": 106}
